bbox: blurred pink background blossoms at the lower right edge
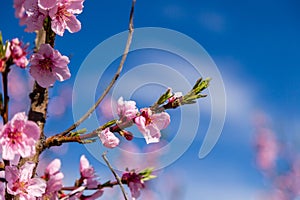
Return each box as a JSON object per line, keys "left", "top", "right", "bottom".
{"left": 255, "top": 116, "right": 300, "bottom": 200}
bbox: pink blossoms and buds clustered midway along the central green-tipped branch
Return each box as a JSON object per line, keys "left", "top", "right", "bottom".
{"left": 99, "top": 97, "right": 171, "bottom": 148}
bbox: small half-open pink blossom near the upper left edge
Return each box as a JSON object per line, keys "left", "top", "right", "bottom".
{"left": 10, "top": 38, "right": 28, "bottom": 68}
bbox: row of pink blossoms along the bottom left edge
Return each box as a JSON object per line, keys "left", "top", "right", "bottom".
{"left": 0, "top": 155, "right": 103, "bottom": 200}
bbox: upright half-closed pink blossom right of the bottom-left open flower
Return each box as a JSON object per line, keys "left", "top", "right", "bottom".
{"left": 42, "top": 159, "right": 64, "bottom": 200}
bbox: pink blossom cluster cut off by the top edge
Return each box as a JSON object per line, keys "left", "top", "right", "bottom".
{"left": 14, "top": 0, "right": 84, "bottom": 36}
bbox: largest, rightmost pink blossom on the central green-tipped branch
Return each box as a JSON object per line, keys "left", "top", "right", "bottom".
{"left": 134, "top": 108, "right": 170, "bottom": 144}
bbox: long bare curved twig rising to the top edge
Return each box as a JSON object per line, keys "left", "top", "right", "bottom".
{"left": 57, "top": 0, "right": 136, "bottom": 136}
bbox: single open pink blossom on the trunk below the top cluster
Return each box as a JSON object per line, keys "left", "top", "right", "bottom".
{"left": 30, "top": 44, "right": 71, "bottom": 88}
